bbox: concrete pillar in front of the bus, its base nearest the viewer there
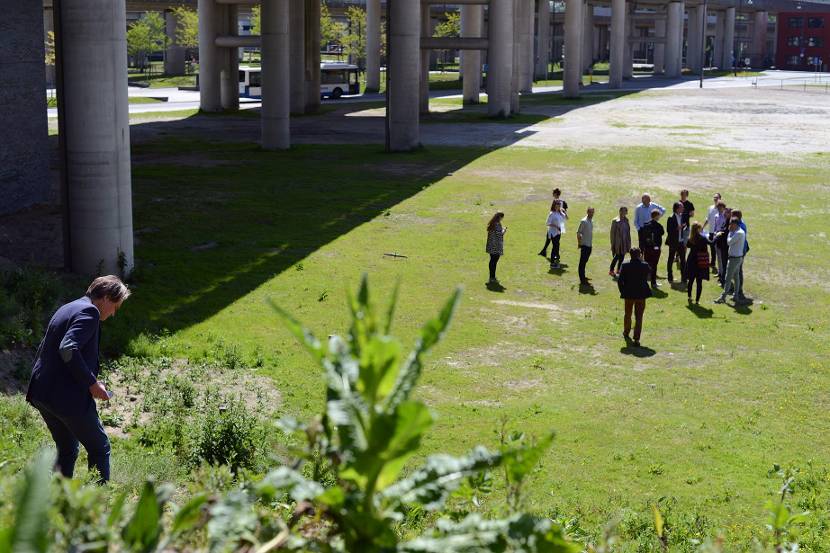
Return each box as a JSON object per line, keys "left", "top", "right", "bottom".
{"left": 260, "top": 0, "right": 294, "bottom": 150}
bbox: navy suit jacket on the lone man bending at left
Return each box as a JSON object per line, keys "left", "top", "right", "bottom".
{"left": 26, "top": 296, "right": 100, "bottom": 416}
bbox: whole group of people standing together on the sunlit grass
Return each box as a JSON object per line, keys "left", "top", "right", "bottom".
{"left": 486, "top": 188, "right": 750, "bottom": 346}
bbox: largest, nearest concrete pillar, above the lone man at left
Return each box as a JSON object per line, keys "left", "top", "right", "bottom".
{"left": 59, "top": 0, "right": 134, "bottom": 275}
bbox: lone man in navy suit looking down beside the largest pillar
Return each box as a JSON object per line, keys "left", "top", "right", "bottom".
{"left": 26, "top": 275, "right": 130, "bottom": 482}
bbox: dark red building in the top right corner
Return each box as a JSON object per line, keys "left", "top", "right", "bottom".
{"left": 775, "top": 12, "right": 830, "bottom": 71}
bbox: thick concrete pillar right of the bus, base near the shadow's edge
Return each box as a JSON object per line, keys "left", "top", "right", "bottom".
{"left": 386, "top": 0, "right": 421, "bottom": 152}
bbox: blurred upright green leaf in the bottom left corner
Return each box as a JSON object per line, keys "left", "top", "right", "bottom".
{"left": 0, "top": 449, "right": 55, "bottom": 553}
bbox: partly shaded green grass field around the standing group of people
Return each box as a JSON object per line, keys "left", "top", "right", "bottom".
{"left": 3, "top": 88, "right": 830, "bottom": 551}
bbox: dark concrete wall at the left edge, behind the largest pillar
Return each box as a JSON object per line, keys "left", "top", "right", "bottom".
{"left": 0, "top": 0, "right": 49, "bottom": 213}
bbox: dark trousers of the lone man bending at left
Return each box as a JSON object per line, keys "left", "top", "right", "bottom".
{"left": 32, "top": 401, "right": 110, "bottom": 483}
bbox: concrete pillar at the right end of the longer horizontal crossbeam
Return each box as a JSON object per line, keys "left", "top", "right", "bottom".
{"left": 487, "top": 0, "right": 513, "bottom": 117}
